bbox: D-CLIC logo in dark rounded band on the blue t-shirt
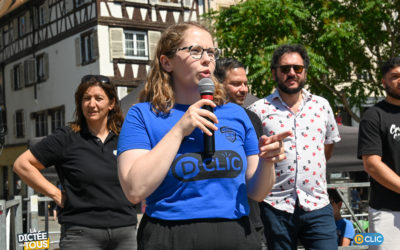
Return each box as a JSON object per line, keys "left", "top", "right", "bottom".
{"left": 171, "top": 150, "right": 243, "bottom": 181}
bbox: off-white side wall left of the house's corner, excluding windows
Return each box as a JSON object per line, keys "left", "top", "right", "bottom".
{"left": 4, "top": 27, "right": 99, "bottom": 144}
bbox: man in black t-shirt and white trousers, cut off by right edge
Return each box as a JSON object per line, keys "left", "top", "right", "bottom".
{"left": 357, "top": 57, "right": 400, "bottom": 249}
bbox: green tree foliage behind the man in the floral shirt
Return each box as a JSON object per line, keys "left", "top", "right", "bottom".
{"left": 206, "top": 0, "right": 400, "bottom": 121}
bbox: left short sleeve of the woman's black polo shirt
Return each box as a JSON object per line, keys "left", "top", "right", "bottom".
{"left": 29, "top": 127, "right": 69, "bottom": 168}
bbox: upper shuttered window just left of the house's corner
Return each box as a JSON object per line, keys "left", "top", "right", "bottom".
{"left": 75, "top": 30, "right": 98, "bottom": 65}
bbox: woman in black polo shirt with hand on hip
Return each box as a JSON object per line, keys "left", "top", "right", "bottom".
{"left": 14, "top": 75, "right": 137, "bottom": 249}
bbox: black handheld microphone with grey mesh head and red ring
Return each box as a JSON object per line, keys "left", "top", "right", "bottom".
{"left": 199, "top": 78, "right": 215, "bottom": 156}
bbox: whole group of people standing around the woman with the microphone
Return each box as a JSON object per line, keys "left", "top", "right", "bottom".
{"left": 14, "top": 22, "right": 400, "bottom": 250}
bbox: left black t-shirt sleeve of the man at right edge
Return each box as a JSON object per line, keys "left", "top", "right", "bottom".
{"left": 357, "top": 107, "right": 382, "bottom": 159}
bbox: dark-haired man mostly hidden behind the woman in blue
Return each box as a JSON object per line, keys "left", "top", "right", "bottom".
{"left": 214, "top": 58, "right": 267, "bottom": 250}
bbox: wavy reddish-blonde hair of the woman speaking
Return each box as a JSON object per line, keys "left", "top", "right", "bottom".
{"left": 139, "top": 22, "right": 226, "bottom": 113}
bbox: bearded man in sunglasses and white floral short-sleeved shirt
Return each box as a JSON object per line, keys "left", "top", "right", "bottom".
{"left": 249, "top": 45, "right": 340, "bottom": 250}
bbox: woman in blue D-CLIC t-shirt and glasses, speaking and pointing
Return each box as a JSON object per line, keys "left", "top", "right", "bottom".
{"left": 118, "top": 22, "right": 290, "bottom": 249}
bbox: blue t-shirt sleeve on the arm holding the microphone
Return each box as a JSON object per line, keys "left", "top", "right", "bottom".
{"left": 118, "top": 103, "right": 152, "bottom": 155}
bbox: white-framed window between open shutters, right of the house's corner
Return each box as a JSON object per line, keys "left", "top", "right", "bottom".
{"left": 124, "top": 31, "right": 148, "bottom": 59}
